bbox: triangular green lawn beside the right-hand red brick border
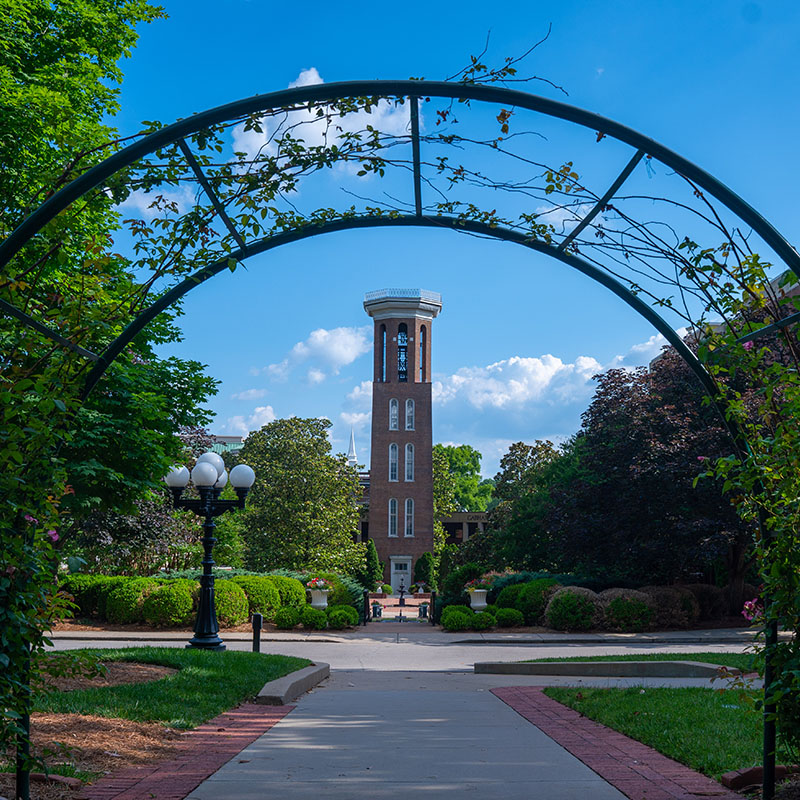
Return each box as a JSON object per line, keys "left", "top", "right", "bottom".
{"left": 545, "top": 687, "right": 787, "bottom": 779}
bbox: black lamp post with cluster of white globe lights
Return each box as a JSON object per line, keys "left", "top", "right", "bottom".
{"left": 164, "top": 453, "right": 256, "bottom": 650}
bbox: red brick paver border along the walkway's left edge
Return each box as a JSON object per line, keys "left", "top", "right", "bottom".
{"left": 80, "top": 703, "right": 295, "bottom": 800}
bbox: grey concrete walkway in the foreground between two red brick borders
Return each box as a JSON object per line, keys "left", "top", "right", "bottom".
{"left": 184, "top": 673, "right": 625, "bottom": 800}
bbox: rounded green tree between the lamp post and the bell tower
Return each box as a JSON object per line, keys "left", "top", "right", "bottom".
{"left": 241, "top": 417, "right": 365, "bottom": 575}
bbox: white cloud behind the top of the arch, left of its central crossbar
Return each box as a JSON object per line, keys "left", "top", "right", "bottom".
{"left": 233, "top": 67, "right": 409, "bottom": 166}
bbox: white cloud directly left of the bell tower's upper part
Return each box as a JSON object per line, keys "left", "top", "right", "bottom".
{"left": 262, "top": 325, "right": 372, "bottom": 384}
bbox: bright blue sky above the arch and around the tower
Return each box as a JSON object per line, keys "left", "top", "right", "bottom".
{"left": 116, "top": 0, "right": 800, "bottom": 475}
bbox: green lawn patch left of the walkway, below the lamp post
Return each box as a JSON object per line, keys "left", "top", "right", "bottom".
{"left": 35, "top": 647, "right": 311, "bottom": 728}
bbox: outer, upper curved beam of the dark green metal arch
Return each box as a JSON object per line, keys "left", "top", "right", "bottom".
{"left": 0, "top": 80, "right": 800, "bottom": 277}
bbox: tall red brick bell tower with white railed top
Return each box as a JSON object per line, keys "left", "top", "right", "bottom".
{"left": 364, "top": 289, "right": 442, "bottom": 591}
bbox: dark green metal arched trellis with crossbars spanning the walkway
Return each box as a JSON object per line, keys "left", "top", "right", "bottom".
{"left": 0, "top": 81, "right": 800, "bottom": 785}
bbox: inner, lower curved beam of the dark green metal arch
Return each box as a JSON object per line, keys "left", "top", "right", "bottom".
{"left": 82, "top": 215, "right": 740, "bottom": 443}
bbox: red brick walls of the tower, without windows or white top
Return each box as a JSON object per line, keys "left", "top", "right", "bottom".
{"left": 369, "top": 317, "right": 433, "bottom": 581}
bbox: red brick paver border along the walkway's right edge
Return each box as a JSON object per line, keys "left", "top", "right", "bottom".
{"left": 492, "top": 686, "right": 743, "bottom": 800}
